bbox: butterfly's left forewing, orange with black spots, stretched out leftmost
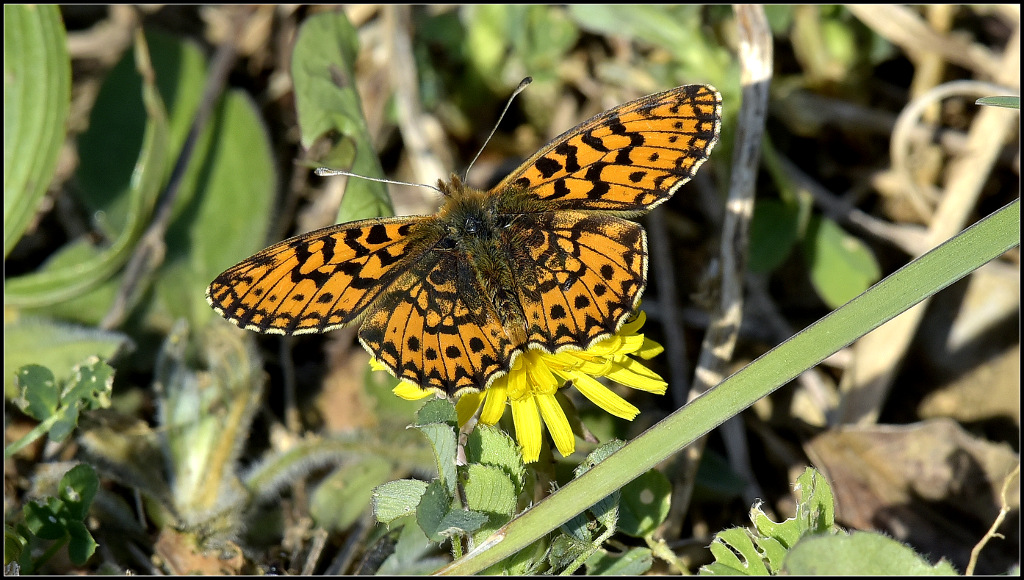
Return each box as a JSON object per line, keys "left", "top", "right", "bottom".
{"left": 206, "top": 216, "right": 433, "bottom": 334}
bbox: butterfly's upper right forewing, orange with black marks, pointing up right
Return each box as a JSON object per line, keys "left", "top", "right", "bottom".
{"left": 490, "top": 85, "right": 722, "bottom": 212}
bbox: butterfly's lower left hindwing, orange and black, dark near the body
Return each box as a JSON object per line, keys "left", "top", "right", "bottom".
{"left": 359, "top": 249, "right": 522, "bottom": 396}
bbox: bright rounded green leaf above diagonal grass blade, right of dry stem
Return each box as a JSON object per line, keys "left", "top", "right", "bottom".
{"left": 803, "top": 216, "right": 882, "bottom": 308}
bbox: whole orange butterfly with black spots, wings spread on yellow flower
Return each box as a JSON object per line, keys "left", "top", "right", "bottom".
{"left": 207, "top": 85, "right": 722, "bottom": 396}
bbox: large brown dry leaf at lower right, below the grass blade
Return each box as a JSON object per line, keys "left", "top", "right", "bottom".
{"left": 805, "top": 419, "right": 1020, "bottom": 574}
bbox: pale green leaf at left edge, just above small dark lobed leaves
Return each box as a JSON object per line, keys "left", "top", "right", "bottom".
{"left": 4, "top": 317, "right": 131, "bottom": 397}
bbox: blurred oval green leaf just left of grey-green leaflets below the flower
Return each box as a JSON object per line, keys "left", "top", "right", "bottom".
{"left": 309, "top": 458, "right": 391, "bottom": 532}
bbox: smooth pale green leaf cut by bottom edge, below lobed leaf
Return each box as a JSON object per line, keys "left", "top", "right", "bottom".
{"left": 782, "top": 532, "right": 956, "bottom": 577}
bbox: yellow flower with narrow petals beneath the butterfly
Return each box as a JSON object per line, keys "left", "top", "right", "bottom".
{"left": 387, "top": 312, "right": 668, "bottom": 463}
